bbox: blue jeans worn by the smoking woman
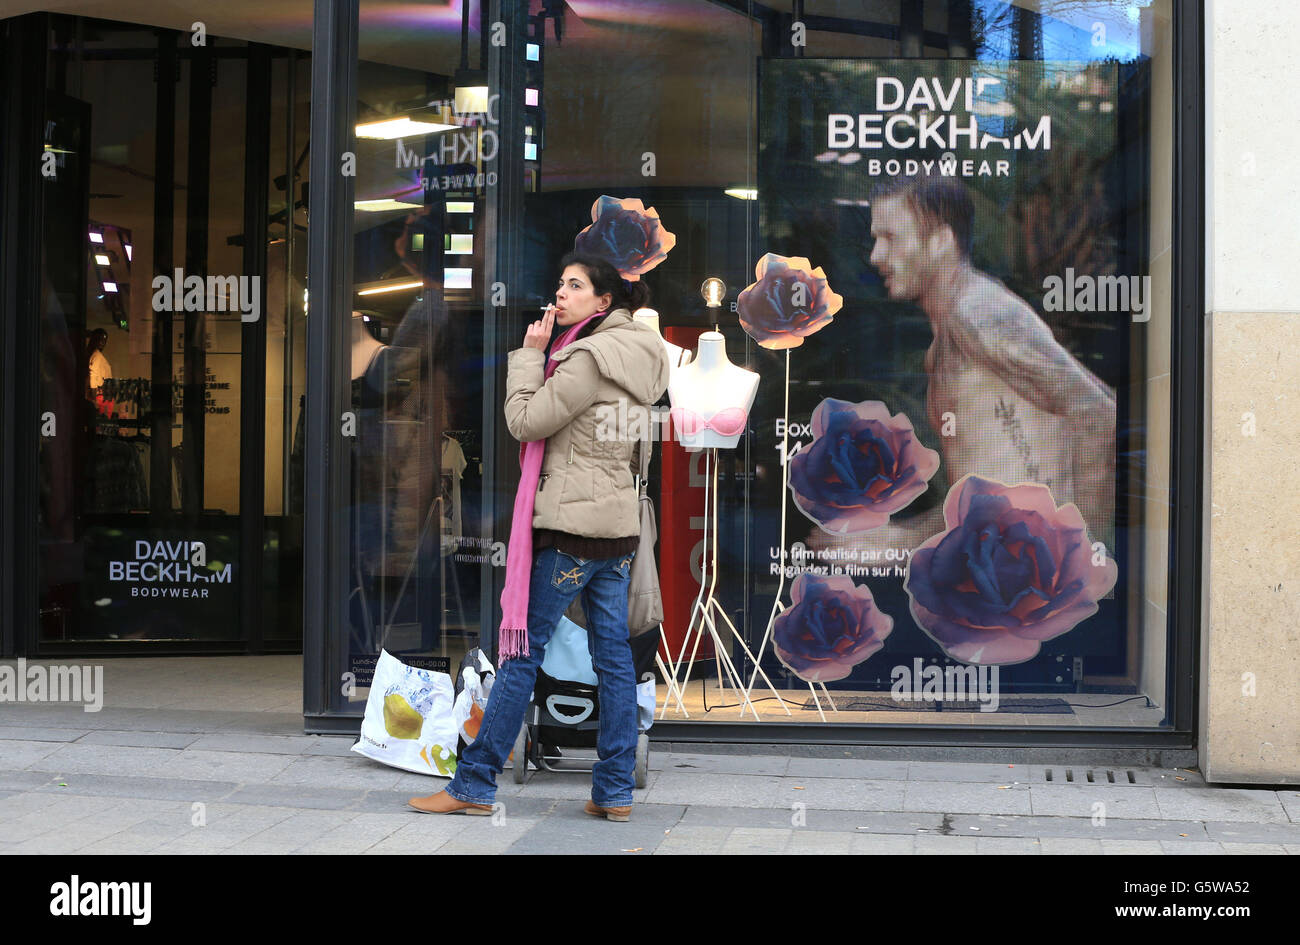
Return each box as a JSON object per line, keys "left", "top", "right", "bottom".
{"left": 446, "top": 549, "right": 637, "bottom": 807}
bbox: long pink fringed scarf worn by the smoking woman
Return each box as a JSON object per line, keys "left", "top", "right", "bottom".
{"left": 497, "top": 312, "right": 605, "bottom": 663}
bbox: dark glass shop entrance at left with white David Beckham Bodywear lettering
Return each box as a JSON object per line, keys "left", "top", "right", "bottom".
{"left": 29, "top": 16, "right": 308, "bottom": 655}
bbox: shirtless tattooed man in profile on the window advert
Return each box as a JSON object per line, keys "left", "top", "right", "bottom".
{"left": 871, "top": 178, "right": 1115, "bottom": 541}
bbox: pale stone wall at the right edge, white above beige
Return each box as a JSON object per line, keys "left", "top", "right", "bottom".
{"left": 1199, "top": 0, "right": 1300, "bottom": 784}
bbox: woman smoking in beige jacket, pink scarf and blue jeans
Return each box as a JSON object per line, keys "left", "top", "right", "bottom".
{"left": 410, "top": 255, "right": 668, "bottom": 820}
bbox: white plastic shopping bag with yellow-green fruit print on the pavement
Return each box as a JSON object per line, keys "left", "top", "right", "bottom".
{"left": 352, "top": 650, "right": 456, "bottom": 777}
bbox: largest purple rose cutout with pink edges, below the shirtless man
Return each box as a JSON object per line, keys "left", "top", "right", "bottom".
{"left": 904, "top": 476, "right": 1119, "bottom": 666}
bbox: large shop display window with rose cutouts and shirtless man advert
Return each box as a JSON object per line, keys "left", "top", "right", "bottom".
{"left": 332, "top": 0, "right": 1174, "bottom": 727}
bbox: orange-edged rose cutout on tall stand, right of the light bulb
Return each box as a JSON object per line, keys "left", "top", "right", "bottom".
{"left": 736, "top": 252, "right": 844, "bottom": 350}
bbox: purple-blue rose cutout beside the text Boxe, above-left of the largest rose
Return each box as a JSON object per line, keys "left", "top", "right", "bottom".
{"left": 790, "top": 398, "right": 939, "bottom": 536}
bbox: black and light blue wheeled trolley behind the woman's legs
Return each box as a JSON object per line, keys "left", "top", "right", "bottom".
{"left": 514, "top": 617, "right": 659, "bottom": 788}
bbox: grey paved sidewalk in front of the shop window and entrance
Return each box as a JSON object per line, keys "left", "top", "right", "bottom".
{"left": 0, "top": 703, "right": 1300, "bottom": 854}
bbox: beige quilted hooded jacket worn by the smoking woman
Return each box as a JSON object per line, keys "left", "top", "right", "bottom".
{"left": 506, "top": 308, "right": 668, "bottom": 538}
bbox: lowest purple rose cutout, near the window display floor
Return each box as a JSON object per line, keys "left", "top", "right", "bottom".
{"left": 772, "top": 575, "right": 893, "bottom": 682}
